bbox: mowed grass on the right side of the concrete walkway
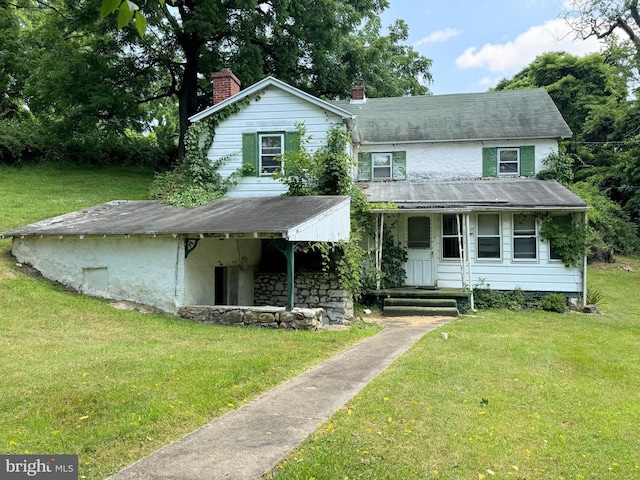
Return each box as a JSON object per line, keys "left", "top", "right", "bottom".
{"left": 268, "top": 259, "right": 640, "bottom": 480}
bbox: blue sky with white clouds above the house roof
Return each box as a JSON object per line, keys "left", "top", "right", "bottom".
{"left": 382, "top": 0, "right": 600, "bottom": 94}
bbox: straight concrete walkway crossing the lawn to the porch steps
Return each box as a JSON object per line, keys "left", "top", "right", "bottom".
{"left": 110, "top": 317, "right": 451, "bottom": 480}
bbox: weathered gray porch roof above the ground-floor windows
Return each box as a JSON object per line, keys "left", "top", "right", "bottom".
{"left": 364, "top": 178, "right": 587, "bottom": 210}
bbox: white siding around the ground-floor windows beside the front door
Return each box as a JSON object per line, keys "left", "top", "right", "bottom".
{"left": 380, "top": 212, "right": 583, "bottom": 294}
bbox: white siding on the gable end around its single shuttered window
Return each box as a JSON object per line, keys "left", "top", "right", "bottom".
{"left": 208, "top": 88, "right": 342, "bottom": 197}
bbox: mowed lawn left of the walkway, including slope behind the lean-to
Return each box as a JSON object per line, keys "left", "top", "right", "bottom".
{"left": 0, "top": 165, "right": 377, "bottom": 479}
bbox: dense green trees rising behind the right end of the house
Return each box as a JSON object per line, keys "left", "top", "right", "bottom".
{"left": 496, "top": 48, "right": 640, "bottom": 256}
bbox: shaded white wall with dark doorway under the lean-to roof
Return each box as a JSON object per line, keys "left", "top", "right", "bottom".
{"left": 183, "top": 238, "right": 262, "bottom": 305}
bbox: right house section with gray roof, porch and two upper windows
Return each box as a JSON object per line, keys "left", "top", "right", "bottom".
{"left": 333, "top": 89, "right": 587, "bottom": 297}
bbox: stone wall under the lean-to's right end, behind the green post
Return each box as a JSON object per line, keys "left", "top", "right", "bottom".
{"left": 253, "top": 273, "right": 353, "bottom": 325}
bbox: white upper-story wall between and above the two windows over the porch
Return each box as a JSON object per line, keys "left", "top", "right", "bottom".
{"left": 356, "top": 139, "right": 558, "bottom": 180}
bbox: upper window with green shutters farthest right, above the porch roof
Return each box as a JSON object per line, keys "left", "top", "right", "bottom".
{"left": 482, "top": 146, "right": 536, "bottom": 177}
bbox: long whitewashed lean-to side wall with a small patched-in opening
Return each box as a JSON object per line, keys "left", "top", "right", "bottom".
{"left": 12, "top": 235, "right": 182, "bottom": 312}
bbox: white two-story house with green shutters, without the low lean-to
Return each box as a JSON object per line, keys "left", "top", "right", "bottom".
{"left": 191, "top": 72, "right": 587, "bottom": 298}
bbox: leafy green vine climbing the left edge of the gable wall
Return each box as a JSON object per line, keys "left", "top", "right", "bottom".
{"left": 149, "top": 98, "right": 251, "bottom": 207}
